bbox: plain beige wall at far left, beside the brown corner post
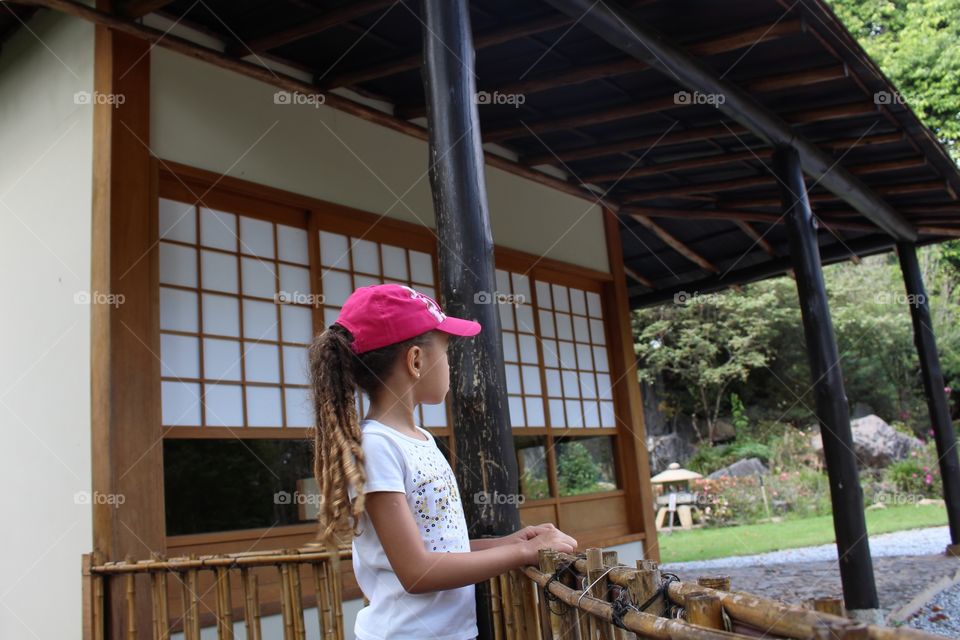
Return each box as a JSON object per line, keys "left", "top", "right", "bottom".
{"left": 0, "top": 6, "right": 93, "bottom": 638}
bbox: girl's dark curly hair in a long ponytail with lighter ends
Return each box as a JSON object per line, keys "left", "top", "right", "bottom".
{"left": 309, "top": 323, "right": 433, "bottom": 548}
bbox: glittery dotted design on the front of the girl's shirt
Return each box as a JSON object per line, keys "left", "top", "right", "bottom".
{"left": 413, "top": 448, "right": 468, "bottom": 551}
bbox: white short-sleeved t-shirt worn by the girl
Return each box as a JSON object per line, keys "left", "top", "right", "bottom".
{"left": 348, "top": 419, "right": 479, "bottom": 640}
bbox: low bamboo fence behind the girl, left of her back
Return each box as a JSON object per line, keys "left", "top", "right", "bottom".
{"left": 83, "top": 547, "right": 350, "bottom": 640}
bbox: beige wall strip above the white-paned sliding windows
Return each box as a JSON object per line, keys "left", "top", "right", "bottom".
{"left": 150, "top": 48, "right": 609, "bottom": 272}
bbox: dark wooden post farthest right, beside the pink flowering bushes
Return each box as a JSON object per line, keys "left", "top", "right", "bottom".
{"left": 897, "top": 242, "right": 960, "bottom": 555}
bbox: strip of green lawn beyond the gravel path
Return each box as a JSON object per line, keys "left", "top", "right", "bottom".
{"left": 657, "top": 505, "right": 947, "bottom": 563}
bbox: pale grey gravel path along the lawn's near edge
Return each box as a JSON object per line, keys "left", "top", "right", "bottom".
{"left": 664, "top": 527, "right": 950, "bottom": 571}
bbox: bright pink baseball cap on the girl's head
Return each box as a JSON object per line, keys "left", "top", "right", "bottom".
{"left": 336, "top": 284, "right": 481, "bottom": 353}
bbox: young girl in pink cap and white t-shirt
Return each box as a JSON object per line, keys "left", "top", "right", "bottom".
{"left": 310, "top": 284, "right": 577, "bottom": 640}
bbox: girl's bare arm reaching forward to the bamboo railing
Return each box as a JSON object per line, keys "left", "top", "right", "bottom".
{"left": 365, "top": 491, "right": 576, "bottom": 593}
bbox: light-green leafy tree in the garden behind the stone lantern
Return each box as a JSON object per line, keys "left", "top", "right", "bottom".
{"left": 633, "top": 289, "right": 783, "bottom": 441}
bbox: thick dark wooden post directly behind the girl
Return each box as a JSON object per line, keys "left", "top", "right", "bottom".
{"left": 420, "top": 0, "right": 520, "bottom": 638}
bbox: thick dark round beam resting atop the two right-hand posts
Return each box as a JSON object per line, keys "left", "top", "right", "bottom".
{"left": 547, "top": 0, "right": 917, "bottom": 241}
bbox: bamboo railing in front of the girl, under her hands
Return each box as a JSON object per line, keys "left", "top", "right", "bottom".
{"left": 490, "top": 548, "right": 944, "bottom": 640}
